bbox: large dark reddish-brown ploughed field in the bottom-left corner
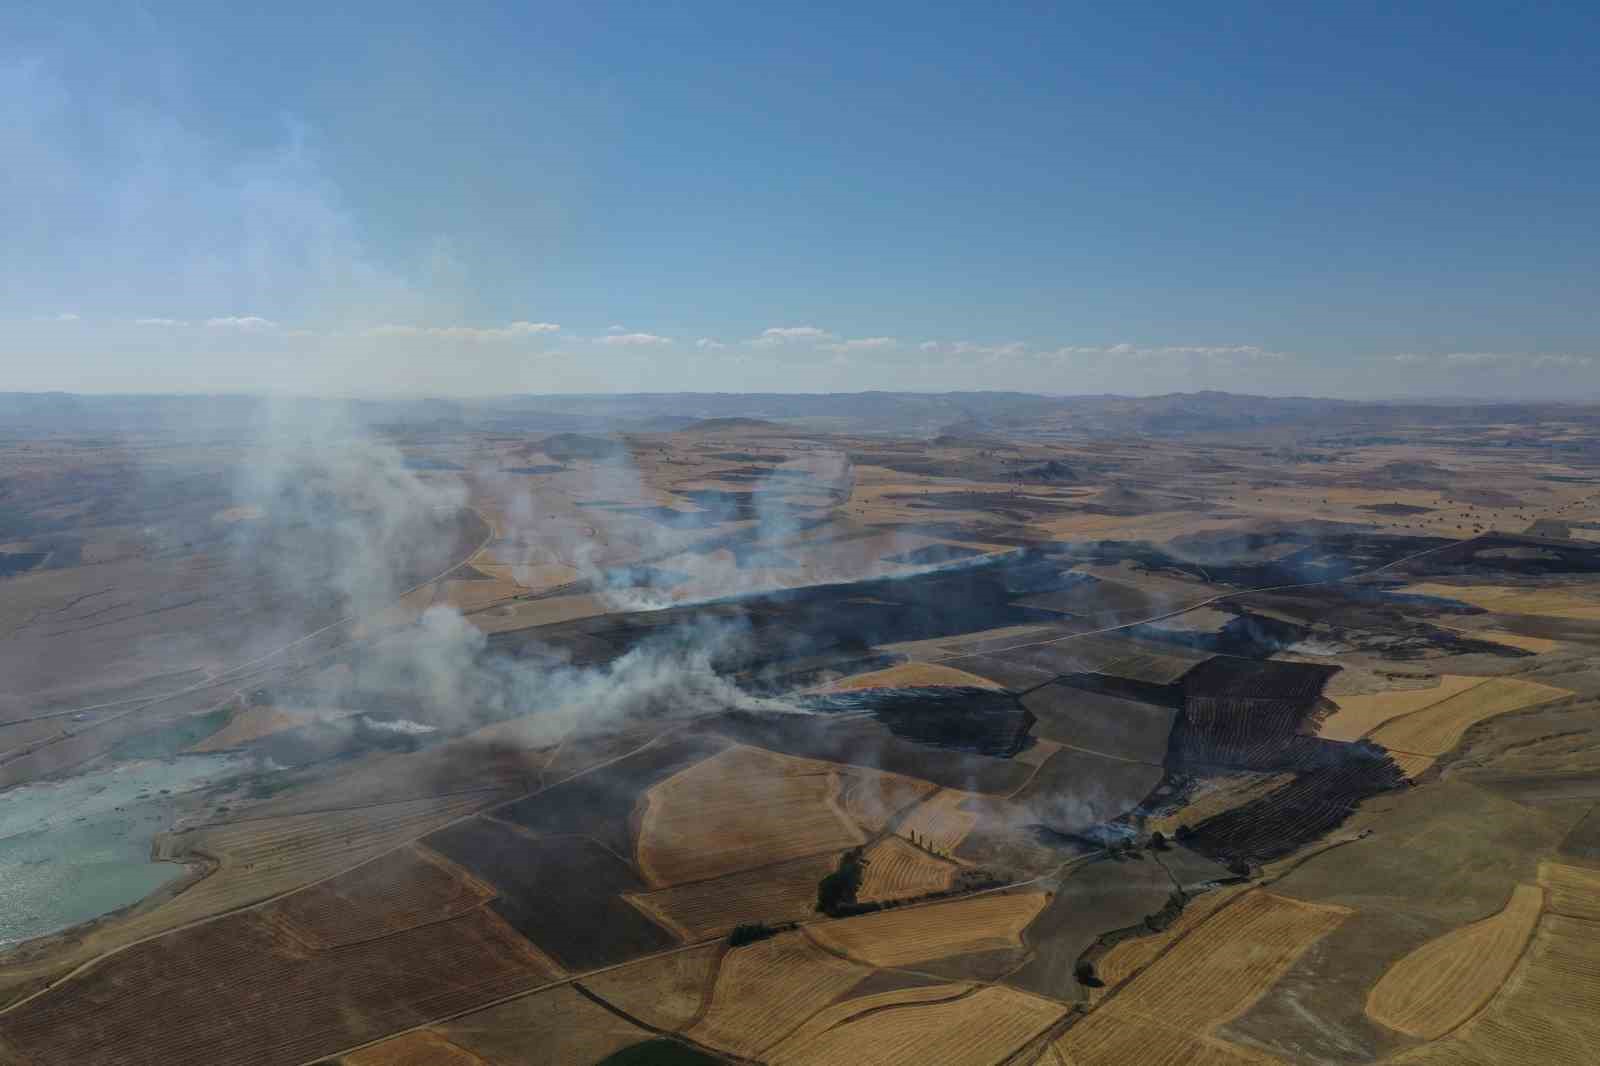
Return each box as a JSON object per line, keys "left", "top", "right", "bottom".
{"left": 0, "top": 908, "right": 557, "bottom": 1066}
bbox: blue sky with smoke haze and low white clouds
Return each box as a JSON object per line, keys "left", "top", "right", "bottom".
{"left": 0, "top": 2, "right": 1600, "bottom": 399}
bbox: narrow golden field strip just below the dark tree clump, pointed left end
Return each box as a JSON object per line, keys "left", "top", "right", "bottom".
{"left": 806, "top": 892, "right": 1048, "bottom": 967}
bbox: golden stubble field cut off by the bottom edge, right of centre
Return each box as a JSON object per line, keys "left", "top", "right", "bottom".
{"left": 768, "top": 986, "right": 1066, "bottom": 1066}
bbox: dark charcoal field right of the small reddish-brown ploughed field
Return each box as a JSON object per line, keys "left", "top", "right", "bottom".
{"left": 426, "top": 818, "right": 677, "bottom": 970}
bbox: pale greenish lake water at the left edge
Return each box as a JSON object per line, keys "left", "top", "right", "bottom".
{"left": 0, "top": 755, "right": 246, "bottom": 944}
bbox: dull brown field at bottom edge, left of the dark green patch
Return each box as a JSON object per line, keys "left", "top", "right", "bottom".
{"left": 435, "top": 986, "right": 650, "bottom": 1066}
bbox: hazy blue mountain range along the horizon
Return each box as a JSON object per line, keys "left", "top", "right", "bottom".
{"left": 0, "top": 392, "right": 1600, "bottom": 439}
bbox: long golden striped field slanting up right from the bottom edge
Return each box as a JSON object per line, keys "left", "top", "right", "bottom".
{"left": 1056, "top": 890, "right": 1350, "bottom": 1066}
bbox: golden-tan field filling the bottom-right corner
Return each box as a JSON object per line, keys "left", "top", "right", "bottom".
{"left": 1387, "top": 914, "right": 1600, "bottom": 1066}
